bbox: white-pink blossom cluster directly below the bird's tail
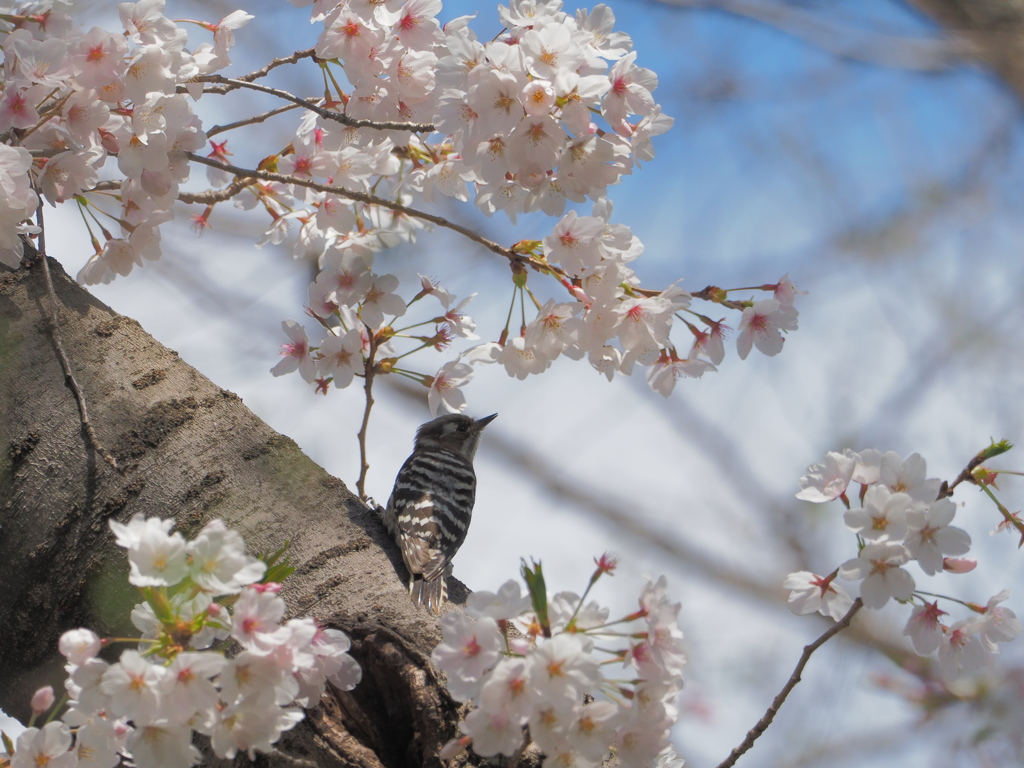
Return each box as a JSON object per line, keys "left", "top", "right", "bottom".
{"left": 432, "top": 557, "right": 685, "bottom": 768}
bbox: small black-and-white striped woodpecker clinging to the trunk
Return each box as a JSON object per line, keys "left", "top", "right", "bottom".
{"left": 378, "top": 414, "right": 498, "bottom": 613}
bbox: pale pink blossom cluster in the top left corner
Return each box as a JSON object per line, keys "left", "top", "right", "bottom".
{"left": 0, "top": 0, "right": 252, "bottom": 274}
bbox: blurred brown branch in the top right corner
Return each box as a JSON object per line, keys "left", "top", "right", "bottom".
{"left": 908, "top": 0, "right": 1024, "bottom": 98}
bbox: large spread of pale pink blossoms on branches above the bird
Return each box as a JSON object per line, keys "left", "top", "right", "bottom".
{"left": 267, "top": 0, "right": 799, "bottom": 405}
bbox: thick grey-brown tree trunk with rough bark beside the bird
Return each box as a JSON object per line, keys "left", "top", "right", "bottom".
{"left": 0, "top": 249, "right": 479, "bottom": 768}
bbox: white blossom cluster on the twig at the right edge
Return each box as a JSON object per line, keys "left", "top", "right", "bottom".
{"left": 784, "top": 449, "right": 1021, "bottom": 681}
